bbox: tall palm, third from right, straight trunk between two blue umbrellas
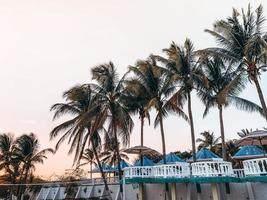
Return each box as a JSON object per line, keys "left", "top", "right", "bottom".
{"left": 157, "top": 39, "right": 205, "bottom": 161}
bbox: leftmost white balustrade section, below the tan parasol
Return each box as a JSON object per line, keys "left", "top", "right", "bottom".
{"left": 123, "top": 166, "right": 153, "bottom": 178}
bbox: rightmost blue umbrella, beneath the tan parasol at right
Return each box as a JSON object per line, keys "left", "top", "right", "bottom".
{"left": 233, "top": 145, "right": 264, "bottom": 159}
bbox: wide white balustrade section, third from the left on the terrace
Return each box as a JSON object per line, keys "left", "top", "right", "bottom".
{"left": 191, "top": 161, "right": 234, "bottom": 177}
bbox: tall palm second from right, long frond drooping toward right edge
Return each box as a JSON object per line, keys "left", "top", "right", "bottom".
{"left": 198, "top": 56, "right": 262, "bottom": 160}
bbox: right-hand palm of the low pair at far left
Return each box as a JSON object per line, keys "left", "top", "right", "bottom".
{"left": 15, "top": 133, "right": 54, "bottom": 183}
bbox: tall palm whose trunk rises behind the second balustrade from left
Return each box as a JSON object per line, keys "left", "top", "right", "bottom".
{"left": 130, "top": 57, "right": 187, "bottom": 164}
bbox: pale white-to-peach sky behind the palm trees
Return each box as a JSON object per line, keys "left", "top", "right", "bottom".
{"left": 0, "top": 0, "right": 267, "bottom": 176}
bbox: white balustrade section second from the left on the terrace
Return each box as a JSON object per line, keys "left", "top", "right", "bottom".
{"left": 153, "top": 162, "right": 190, "bottom": 178}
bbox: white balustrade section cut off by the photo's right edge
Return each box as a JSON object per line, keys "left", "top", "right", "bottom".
{"left": 243, "top": 158, "right": 267, "bottom": 176}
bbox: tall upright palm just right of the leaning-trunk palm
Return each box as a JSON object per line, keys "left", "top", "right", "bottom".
{"left": 91, "top": 62, "right": 134, "bottom": 194}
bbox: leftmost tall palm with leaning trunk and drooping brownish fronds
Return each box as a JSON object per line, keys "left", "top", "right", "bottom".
{"left": 50, "top": 85, "right": 110, "bottom": 197}
